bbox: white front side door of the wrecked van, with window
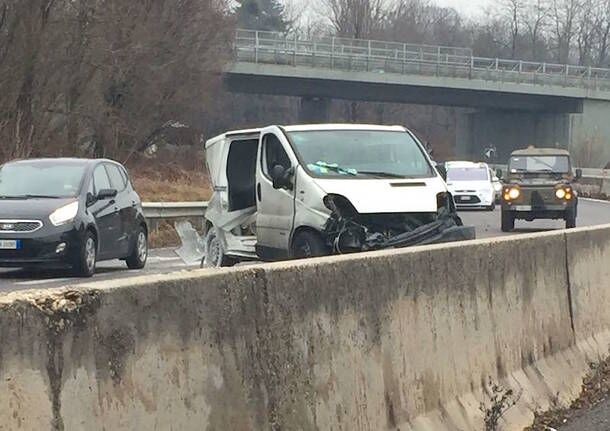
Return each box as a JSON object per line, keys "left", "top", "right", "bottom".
{"left": 256, "top": 127, "right": 297, "bottom": 260}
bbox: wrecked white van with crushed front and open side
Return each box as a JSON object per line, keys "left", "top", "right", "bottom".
{"left": 203, "top": 124, "right": 475, "bottom": 267}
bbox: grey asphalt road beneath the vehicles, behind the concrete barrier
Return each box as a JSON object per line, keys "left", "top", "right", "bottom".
{"left": 0, "top": 200, "right": 610, "bottom": 293}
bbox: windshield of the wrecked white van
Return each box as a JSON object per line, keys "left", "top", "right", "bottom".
{"left": 288, "top": 130, "right": 434, "bottom": 178}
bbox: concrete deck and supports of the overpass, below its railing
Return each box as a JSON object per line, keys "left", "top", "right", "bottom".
{"left": 224, "top": 65, "right": 610, "bottom": 167}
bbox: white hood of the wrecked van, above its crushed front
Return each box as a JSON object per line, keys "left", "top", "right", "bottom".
{"left": 315, "top": 177, "right": 447, "bottom": 214}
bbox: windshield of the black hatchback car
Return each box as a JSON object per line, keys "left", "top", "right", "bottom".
{"left": 0, "top": 162, "right": 85, "bottom": 199}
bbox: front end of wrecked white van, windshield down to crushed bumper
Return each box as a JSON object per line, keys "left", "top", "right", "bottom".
{"left": 286, "top": 128, "right": 475, "bottom": 253}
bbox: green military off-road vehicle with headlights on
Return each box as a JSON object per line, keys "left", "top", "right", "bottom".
{"left": 502, "top": 147, "right": 582, "bottom": 232}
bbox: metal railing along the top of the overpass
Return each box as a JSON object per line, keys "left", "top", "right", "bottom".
{"left": 234, "top": 30, "right": 610, "bottom": 90}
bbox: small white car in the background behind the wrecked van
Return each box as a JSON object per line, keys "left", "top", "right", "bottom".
{"left": 445, "top": 162, "right": 501, "bottom": 211}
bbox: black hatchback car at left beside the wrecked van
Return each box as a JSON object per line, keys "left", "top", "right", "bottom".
{"left": 0, "top": 159, "right": 148, "bottom": 276}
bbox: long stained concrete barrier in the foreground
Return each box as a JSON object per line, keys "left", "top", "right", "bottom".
{"left": 0, "top": 227, "right": 610, "bottom": 431}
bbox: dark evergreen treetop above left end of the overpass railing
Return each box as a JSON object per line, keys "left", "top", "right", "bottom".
{"left": 235, "top": 0, "right": 288, "bottom": 32}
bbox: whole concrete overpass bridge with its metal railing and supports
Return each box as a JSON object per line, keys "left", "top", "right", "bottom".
{"left": 225, "top": 30, "right": 610, "bottom": 167}
